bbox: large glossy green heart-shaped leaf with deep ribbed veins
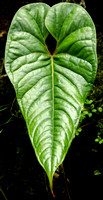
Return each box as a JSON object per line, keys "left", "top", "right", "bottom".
{"left": 5, "top": 3, "right": 97, "bottom": 189}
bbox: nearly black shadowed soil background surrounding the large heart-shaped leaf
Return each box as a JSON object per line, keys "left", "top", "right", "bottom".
{"left": 0, "top": 0, "right": 103, "bottom": 200}
